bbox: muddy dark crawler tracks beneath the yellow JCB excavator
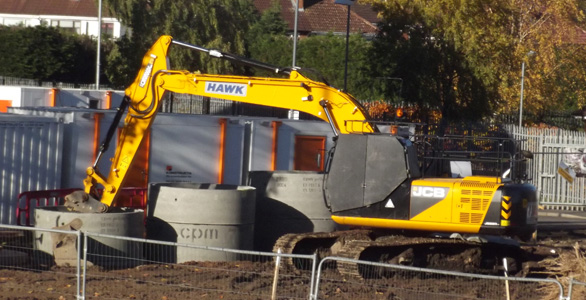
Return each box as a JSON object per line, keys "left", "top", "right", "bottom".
{"left": 274, "top": 230, "right": 523, "bottom": 279}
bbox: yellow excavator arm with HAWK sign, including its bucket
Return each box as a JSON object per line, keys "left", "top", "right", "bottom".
{"left": 65, "top": 36, "right": 376, "bottom": 212}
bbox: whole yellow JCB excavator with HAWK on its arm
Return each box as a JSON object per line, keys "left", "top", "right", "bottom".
{"left": 65, "top": 36, "right": 537, "bottom": 272}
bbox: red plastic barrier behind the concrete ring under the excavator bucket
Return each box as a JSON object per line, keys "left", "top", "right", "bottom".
{"left": 16, "top": 188, "right": 147, "bottom": 226}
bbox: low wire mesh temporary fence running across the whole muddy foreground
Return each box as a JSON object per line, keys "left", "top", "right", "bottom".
{"left": 0, "top": 225, "right": 586, "bottom": 300}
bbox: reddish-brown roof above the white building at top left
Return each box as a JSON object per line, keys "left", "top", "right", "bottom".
{"left": 0, "top": 0, "right": 109, "bottom": 17}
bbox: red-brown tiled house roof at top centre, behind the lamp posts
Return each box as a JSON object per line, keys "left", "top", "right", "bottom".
{"left": 254, "top": 0, "right": 377, "bottom": 34}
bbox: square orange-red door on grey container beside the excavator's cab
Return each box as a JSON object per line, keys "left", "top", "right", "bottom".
{"left": 293, "top": 135, "right": 326, "bottom": 171}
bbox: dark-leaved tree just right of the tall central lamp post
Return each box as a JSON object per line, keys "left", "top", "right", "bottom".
{"left": 362, "top": 1, "right": 496, "bottom": 119}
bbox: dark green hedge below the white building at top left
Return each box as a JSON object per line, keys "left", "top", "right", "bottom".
{"left": 0, "top": 26, "right": 95, "bottom": 83}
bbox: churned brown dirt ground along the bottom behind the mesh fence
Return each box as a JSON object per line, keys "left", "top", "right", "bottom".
{"left": 0, "top": 229, "right": 586, "bottom": 300}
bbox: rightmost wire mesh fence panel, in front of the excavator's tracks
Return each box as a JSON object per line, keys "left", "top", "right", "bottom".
{"left": 313, "top": 257, "right": 563, "bottom": 300}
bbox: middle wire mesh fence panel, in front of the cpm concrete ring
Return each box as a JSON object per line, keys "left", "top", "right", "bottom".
{"left": 83, "top": 233, "right": 316, "bottom": 299}
